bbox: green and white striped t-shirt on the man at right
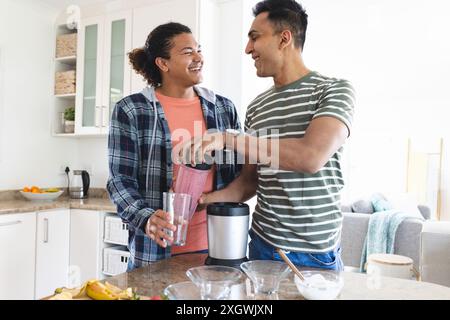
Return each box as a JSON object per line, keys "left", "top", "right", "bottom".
{"left": 245, "top": 72, "right": 354, "bottom": 253}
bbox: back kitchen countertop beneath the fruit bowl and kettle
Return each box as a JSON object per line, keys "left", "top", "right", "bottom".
{"left": 0, "top": 190, "right": 117, "bottom": 215}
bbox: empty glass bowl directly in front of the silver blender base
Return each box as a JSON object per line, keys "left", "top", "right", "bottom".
{"left": 186, "top": 266, "right": 245, "bottom": 300}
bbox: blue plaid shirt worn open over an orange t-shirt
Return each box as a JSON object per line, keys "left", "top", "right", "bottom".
{"left": 107, "top": 87, "right": 241, "bottom": 267}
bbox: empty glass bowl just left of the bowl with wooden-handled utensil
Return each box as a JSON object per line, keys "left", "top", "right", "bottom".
{"left": 241, "top": 260, "right": 291, "bottom": 300}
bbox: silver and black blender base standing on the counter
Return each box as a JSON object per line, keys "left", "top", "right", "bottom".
{"left": 205, "top": 202, "right": 250, "bottom": 268}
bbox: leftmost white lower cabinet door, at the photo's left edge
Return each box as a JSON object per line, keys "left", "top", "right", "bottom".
{"left": 0, "top": 212, "right": 36, "bottom": 300}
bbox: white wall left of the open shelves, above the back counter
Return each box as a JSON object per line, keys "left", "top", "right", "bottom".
{"left": 0, "top": 0, "right": 77, "bottom": 190}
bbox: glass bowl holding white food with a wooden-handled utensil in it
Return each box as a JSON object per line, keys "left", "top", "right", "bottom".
{"left": 294, "top": 270, "right": 344, "bottom": 300}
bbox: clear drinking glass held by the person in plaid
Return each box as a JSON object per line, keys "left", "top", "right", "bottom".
{"left": 163, "top": 192, "right": 191, "bottom": 246}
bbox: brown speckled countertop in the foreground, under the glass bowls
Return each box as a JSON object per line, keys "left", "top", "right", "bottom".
{"left": 106, "top": 254, "right": 450, "bottom": 300}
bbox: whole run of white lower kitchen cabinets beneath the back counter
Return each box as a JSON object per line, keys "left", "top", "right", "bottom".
{"left": 0, "top": 209, "right": 125, "bottom": 300}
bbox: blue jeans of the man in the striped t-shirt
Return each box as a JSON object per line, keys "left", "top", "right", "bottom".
{"left": 248, "top": 230, "right": 344, "bottom": 271}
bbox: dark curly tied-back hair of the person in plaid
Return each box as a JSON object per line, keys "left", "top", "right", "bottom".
{"left": 128, "top": 22, "right": 192, "bottom": 87}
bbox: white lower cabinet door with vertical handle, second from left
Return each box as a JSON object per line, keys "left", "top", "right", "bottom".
{"left": 35, "top": 209, "right": 70, "bottom": 299}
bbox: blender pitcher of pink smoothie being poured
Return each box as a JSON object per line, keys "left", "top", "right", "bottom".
{"left": 174, "top": 163, "right": 212, "bottom": 220}
